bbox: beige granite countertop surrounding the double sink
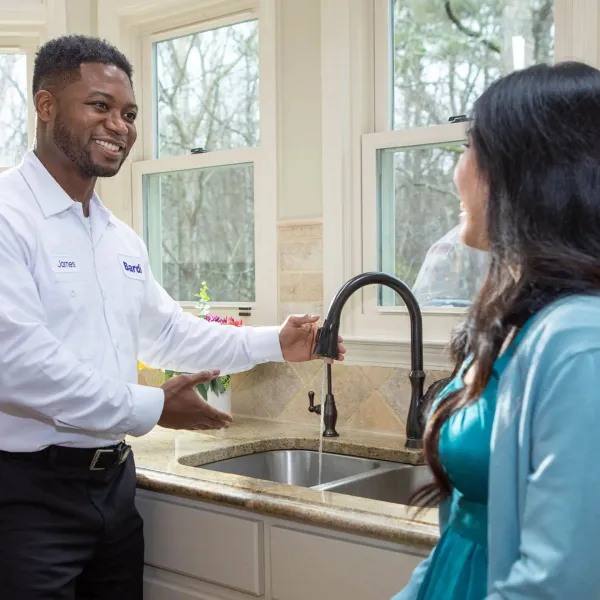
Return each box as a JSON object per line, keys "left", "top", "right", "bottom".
{"left": 128, "top": 417, "right": 439, "bottom": 547}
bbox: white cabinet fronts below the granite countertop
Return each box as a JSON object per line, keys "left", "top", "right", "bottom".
{"left": 136, "top": 491, "right": 427, "bottom": 600}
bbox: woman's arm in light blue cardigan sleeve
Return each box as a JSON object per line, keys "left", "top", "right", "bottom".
{"left": 486, "top": 350, "right": 600, "bottom": 600}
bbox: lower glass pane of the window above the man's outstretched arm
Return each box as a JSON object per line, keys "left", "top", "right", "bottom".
{"left": 145, "top": 163, "right": 256, "bottom": 303}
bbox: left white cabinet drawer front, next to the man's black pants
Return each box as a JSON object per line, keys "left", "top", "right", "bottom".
{"left": 136, "top": 494, "right": 264, "bottom": 596}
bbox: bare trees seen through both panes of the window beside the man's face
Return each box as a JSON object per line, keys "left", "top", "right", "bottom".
{"left": 145, "top": 20, "right": 260, "bottom": 302}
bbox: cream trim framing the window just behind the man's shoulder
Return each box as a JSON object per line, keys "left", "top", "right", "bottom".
{"left": 124, "top": 0, "right": 278, "bottom": 325}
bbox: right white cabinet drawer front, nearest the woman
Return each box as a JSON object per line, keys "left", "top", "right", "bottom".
{"left": 271, "top": 527, "right": 423, "bottom": 600}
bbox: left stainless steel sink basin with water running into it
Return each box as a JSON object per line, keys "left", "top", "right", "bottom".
{"left": 197, "top": 450, "right": 398, "bottom": 487}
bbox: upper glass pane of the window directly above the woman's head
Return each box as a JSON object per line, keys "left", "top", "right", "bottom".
{"left": 390, "top": 0, "right": 554, "bottom": 129}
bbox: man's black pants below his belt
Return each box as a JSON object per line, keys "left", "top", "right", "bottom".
{"left": 0, "top": 442, "right": 144, "bottom": 600}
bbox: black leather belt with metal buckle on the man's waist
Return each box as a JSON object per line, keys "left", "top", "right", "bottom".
{"left": 2, "top": 442, "right": 131, "bottom": 471}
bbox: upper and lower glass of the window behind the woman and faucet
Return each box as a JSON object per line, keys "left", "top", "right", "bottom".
{"left": 376, "top": 0, "right": 554, "bottom": 308}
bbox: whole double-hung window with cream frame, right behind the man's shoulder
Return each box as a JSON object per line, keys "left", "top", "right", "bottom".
{"left": 133, "top": 0, "right": 277, "bottom": 324}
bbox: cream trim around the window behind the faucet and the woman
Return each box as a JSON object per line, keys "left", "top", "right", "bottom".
{"left": 321, "top": 0, "right": 600, "bottom": 369}
